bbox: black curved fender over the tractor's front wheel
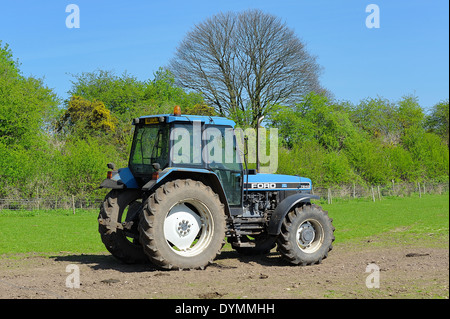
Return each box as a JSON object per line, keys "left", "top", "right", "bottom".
{"left": 267, "top": 193, "right": 320, "bottom": 235}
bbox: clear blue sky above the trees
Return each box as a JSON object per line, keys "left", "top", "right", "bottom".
{"left": 0, "top": 0, "right": 449, "bottom": 109}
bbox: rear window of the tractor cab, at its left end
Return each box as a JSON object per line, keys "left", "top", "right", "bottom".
{"left": 130, "top": 125, "right": 169, "bottom": 174}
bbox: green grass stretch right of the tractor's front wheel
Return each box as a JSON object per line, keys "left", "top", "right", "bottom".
{"left": 321, "top": 193, "right": 449, "bottom": 247}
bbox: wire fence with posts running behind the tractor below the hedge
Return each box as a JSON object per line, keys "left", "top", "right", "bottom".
{"left": 0, "top": 181, "right": 449, "bottom": 212}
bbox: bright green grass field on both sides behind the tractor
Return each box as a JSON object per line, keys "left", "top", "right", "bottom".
{"left": 0, "top": 194, "right": 449, "bottom": 257}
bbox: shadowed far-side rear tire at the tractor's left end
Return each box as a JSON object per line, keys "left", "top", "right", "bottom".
{"left": 98, "top": 189, "right": 148, "bottom": 264}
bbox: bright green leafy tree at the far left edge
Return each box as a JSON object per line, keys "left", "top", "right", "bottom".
{"left": 0, "top": 42, "right": 59, "bottom": 197}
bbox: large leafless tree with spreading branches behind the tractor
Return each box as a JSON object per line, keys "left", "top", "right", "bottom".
{"left": 169, "top": 10, "right": 322, "bottom": 126}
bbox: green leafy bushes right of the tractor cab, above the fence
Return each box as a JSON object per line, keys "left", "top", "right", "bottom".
{"left": 269, "top": 94, "right": 449, "bottom": 186}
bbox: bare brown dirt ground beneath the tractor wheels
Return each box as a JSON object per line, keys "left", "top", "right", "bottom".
{"left": 0, "top": 241, "right": 449, "bottom": 299}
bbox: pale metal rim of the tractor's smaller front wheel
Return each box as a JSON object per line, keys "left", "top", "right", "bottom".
{"left": 296, "top": 219, "right": 324, "bottom": 253}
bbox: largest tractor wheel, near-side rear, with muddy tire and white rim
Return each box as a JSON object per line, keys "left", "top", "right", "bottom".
{"left": 139, "top": 179, "right": 226, "bottom": 270}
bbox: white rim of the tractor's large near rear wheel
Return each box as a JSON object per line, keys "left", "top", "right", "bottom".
{"left": 164, "top": 199, "right": 214, "bottom": 257}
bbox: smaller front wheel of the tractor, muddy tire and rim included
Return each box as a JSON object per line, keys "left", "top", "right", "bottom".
{"left": 277, "top": 203, "right": 334, "bottom": 266}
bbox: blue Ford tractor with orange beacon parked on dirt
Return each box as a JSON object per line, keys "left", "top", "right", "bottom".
{"left": 98, "top": 107, "right": 334, "bottom": 269}
